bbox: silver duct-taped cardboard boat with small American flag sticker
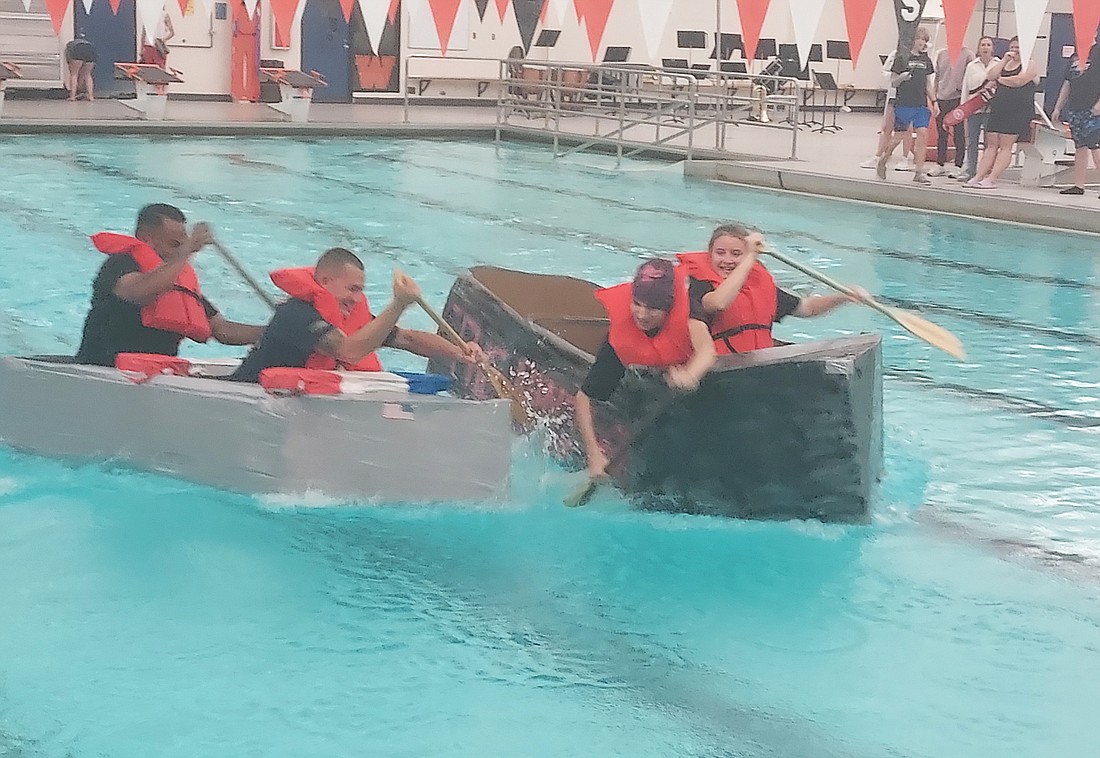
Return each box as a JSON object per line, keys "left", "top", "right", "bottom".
{"left": 0, "top": 356, "right": 514, "bottom": 502}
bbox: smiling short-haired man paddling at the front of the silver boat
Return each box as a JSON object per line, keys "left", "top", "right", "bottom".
{"left": 229, "top": 248, "right": 485, "bottom": 382}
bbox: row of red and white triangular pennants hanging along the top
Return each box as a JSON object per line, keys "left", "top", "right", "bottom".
{"left": 23, "top": 0, "right": 1100, "bottom": 65}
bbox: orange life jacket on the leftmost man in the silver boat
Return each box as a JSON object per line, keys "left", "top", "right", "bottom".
{"left": 91, "top": 232, "right": 211, "bottom": 342}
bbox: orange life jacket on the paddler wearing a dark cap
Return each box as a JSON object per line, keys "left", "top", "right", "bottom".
{"left": 596, "top": 266, "right": 695, "bottom": 366}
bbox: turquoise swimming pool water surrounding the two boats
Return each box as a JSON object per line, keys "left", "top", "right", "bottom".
{"left": 0, "top": 138, "right": 1100, "bottom": 758}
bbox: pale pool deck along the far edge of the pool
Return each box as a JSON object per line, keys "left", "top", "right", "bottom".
{"left": 0, "top": 98, "right": 1100, "bottom": 233}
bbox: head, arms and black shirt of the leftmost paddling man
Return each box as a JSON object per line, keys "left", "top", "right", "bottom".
{"left": 76, "top": 204, "right": 263, "bottom": 366}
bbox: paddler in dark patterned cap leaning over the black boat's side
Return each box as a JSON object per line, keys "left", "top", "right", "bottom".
{"left": 574, "top": 259, "right": 715, "bottom": 480}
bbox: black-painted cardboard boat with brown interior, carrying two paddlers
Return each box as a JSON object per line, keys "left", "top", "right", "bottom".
{"left": 429, "top": 266, "right": 882, "bottom": 521}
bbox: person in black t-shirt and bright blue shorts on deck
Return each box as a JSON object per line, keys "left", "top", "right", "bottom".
{"left": 876, "top": 26, "right": 936, "bottom": 184}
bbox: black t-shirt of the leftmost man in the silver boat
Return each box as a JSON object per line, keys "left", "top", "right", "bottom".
{"left": 76, "top": 255, "right": 218, "bottom": 366}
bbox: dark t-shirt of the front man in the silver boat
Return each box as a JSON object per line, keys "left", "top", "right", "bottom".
{"left": 229, "top": 299, "right": 336, "bottom": 382}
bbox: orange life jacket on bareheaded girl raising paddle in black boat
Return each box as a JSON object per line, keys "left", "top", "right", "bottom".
{"left": 677, "top": 252, "right": 778, "bottom": 355}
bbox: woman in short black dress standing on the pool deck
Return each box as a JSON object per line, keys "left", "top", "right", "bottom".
{"left": 964, "top": 37, "right": 1038, "bottom": 189}
